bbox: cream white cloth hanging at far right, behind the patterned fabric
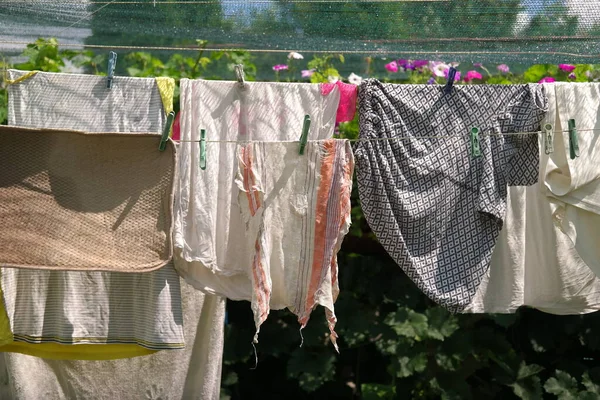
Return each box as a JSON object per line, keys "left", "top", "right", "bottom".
{"left": 465, "top": 83, "right": 600, "bottom": 314}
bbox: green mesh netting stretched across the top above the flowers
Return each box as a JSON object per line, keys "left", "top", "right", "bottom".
{"left": 0, "top": 0, "right": 600, "bottom": 72}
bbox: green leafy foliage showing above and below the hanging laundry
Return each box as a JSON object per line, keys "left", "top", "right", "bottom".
{"left": 0, "top": 40, "right": 600, "bottom": 400}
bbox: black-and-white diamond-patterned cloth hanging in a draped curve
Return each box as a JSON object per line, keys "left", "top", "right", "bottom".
{"left": 355, "top": 80, "right": 546, "bottom": 312}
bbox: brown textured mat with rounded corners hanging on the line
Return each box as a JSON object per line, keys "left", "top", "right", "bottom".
{"left": 0, "top": 127, "right": 175, "bottom": 273}
